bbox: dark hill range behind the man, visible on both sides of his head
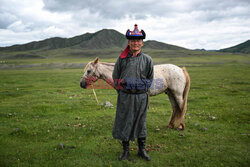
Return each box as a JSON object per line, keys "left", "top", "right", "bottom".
{"left": 0, "top": 29, "right": 184, "bottom": 52}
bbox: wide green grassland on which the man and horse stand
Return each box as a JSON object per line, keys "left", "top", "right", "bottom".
{"left": 0, "top": 50, "right": 250, "bottom": 167}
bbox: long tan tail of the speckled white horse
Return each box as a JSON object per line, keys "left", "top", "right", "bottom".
{"left": 182, "top": 67, "right": 190, "bottom": 119}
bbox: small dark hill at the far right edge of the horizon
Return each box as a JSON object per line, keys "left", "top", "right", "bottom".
{"left": 219, "top": 40, "right": 250, "bottom": 53}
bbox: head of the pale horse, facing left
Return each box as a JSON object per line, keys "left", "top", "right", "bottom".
{"left": 80, "top": 58, "right": 100, "bottom": 89}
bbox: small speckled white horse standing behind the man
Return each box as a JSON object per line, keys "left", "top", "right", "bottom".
{"left": 80, "top": 58, "right": 190, "bottom": 130}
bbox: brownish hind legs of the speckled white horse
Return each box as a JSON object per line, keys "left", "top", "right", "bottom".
{"left": 167, "top": 90, "right": 185, "bottom": 130}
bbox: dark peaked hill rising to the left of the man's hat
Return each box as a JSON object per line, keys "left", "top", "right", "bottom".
{"left": 0, "top": 29, "right": 126, "bottom": 51}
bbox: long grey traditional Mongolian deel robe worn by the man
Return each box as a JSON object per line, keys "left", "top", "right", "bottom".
{"left": 113, "top": 52, "right": 154, "bottom": 141}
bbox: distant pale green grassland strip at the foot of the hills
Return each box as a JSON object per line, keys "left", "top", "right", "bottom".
{"left": 0, "top": 48, "right": 249, "bottom": 69}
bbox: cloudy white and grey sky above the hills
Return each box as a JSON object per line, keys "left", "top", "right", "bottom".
{"left": 0, "top": 0, "right": 250, "bottom": 50}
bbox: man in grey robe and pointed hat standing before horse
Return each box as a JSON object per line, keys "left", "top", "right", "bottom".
{"left": 112, "top": 25, "right": 154, "bottom": 161}
